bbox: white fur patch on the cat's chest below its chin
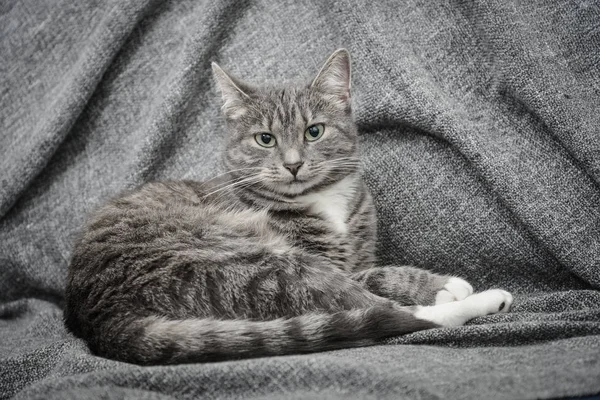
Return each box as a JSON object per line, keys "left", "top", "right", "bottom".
{"left": 296, "top": 175, "right": 359, "bottom": 233}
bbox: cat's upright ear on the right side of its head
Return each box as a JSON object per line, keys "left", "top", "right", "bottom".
{"left": 310, "top": 49, "right": 351, "bottom": 100}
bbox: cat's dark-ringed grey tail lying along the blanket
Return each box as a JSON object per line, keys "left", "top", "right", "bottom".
{"left": 99, "top": 305, "right": 437, "bottom": 365}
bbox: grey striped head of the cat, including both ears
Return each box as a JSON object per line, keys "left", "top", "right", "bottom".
{"left": 213, "top": 49, "right": 358, "bottom": 196}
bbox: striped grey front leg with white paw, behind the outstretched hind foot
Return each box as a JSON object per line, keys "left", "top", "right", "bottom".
{"left": 350, "top": 266, "right": 473, "bottom": 305}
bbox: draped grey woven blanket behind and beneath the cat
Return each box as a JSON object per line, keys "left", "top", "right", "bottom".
{"left": 0, "top": 0, "right": 600, "bottom": 399}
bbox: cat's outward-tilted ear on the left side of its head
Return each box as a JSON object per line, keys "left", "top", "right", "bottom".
{"left": 212, "top": 62, "right": 254, "bottom": 119}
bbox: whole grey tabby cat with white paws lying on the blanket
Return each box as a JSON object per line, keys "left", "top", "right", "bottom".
{"left": 65, "top": 49, "right": 512, "bottom": 364}
